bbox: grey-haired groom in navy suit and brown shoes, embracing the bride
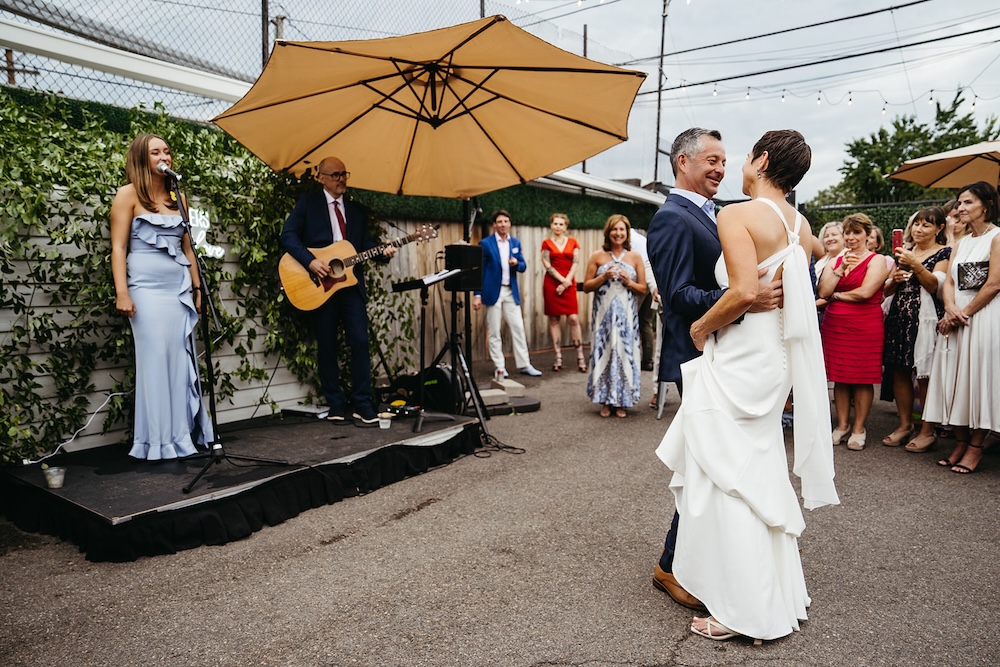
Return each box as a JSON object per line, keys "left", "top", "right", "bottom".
{"left": 646, "top": 127, "right": 781, "bottom": 610}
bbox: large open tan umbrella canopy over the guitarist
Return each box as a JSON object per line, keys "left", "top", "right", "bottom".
{"left": 213, "top": 16, "right": 645, "bottom": 198}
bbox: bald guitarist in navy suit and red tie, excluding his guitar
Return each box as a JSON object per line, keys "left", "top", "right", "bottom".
{"left": 281, "top": 157, "right": 397, "bottom": 428}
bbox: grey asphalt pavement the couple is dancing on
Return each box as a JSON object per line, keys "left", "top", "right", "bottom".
{"left": 0, "top": 354, "right": 1000, "bottom": 667}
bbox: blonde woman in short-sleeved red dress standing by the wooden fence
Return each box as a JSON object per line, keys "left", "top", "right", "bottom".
{"left": 542, "top": 213, "right": 587, "bottom": 373}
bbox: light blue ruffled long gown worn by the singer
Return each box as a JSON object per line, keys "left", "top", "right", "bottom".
{"left": 127, "top": 213, "right": 213, "bottom": 460}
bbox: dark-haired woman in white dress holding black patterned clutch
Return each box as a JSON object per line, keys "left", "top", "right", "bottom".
{"left": 923, "top": 181, "right": 1000, "bottom": 474}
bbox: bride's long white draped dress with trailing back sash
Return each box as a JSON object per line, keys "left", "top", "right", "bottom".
{"left": 656, "top": 199, "right": 840, "bottom": 639}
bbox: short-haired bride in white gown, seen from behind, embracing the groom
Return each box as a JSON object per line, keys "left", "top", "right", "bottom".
{"left": 656, "top": 130, "right": 840, "bottom": 640}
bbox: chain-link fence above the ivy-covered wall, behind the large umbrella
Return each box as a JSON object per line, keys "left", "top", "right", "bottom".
{"left": 0, "top": 0, "right": 656, "bottom": 180}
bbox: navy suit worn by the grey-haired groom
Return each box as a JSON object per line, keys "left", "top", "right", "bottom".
{"left": 646, "top": 189, "right": 723, "bottom": 572}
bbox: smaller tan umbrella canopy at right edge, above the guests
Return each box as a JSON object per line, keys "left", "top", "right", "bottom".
{"left": 889, "top": 141, "right": 1000, "bottom": 188}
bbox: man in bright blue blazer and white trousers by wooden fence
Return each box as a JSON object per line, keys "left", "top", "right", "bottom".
{"left": 472, "top": 211, "right": 542, "bottom": 377}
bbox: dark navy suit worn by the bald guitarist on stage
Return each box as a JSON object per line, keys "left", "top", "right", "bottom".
{"left": 281, "top": 190, "right": 388, "bottom": 415}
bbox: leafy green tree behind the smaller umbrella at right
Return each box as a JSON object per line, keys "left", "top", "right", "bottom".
{"left": 810, "top": 91, "right": 1000, "bottom": 206}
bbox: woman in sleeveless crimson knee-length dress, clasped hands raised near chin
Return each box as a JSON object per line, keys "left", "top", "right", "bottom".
{"left": 817, "top": 213, "right": 889, "bottom": 450}
